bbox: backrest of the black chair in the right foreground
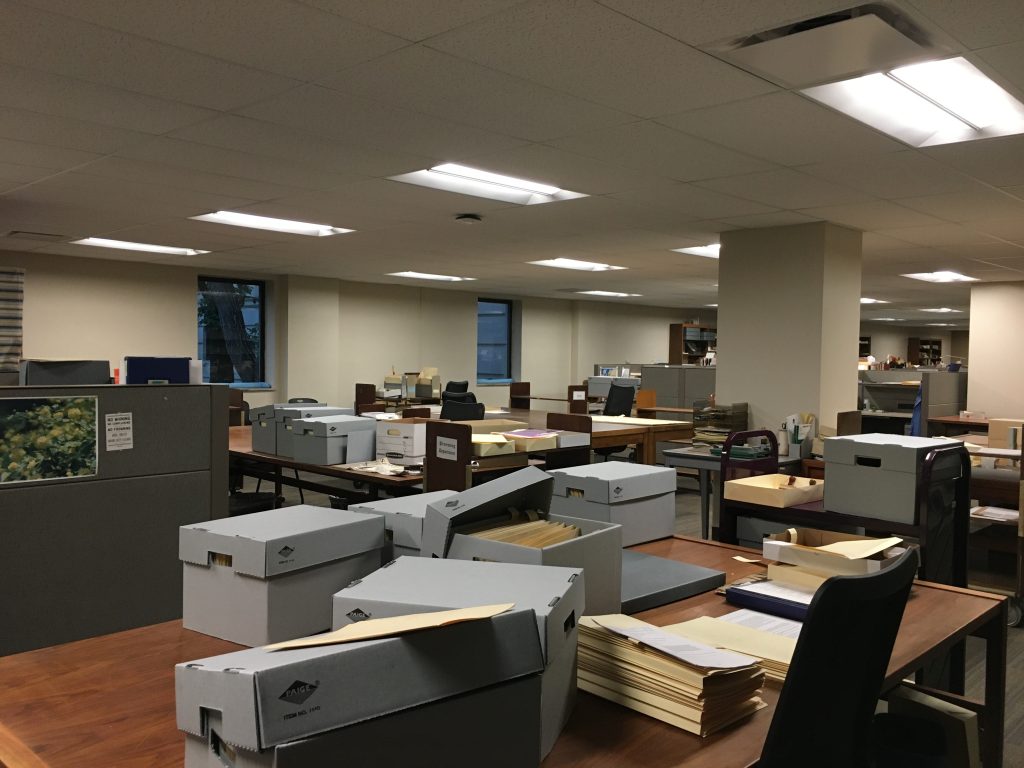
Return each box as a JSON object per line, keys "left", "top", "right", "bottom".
{"left": 758, "top": 550, "right": 918, "bottom": 768}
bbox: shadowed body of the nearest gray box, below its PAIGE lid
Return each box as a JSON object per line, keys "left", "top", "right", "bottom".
{"left": 185, "top": 675, "right": 541, "bottom": 768}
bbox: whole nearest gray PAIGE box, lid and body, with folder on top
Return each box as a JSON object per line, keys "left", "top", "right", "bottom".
{"left": 174, "top": 614, "right": 544, "bottom": 767}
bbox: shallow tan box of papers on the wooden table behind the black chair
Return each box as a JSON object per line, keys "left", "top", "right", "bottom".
{"left": 762, "top": 528, "right": 916, "bottom": 575}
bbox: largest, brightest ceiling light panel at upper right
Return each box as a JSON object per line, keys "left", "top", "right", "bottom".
{"left": 803, "top": 56, "right": 1024, "bottom": 146}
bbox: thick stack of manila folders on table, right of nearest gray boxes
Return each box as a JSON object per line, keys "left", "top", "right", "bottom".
{"left": 578, "top": 614, "right": 765, "bottom": 736}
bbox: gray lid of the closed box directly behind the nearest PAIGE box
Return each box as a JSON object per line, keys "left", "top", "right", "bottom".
{"left": 334, "top": 557, "right": 586, "bottom": 657}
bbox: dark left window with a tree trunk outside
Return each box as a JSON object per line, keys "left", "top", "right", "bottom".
{"left": 198, "top": 278, "right": 268, "bottom": 387}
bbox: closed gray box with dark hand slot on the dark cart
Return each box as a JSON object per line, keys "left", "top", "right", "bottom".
{"left": 824, "top": 434, "right": 961, "bottom": 524}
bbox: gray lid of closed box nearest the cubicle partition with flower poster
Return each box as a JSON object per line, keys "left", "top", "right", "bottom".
{"left": 178, "top": 505, "right": 386, "bottom": 579}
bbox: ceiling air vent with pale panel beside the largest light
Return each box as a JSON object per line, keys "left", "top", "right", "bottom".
{"left": 713, "top": 3, "right": 944, "bottom": 88}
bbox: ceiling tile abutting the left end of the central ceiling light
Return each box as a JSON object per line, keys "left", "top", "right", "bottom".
{"left": 165, "top": 115, "right": 431, "bottom": 180}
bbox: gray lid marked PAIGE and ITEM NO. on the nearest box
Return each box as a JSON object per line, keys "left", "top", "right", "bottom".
{"left": 174, "top": 610, "right": 544, "bottom": 750}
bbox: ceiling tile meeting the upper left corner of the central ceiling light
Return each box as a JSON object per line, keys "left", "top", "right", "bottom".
{"left": 242, "top": 86, "right": 523, "bottom": 165}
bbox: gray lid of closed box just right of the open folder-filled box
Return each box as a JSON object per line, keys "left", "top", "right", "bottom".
{"left": 550, "top": 462, "right": 676, "bottom": 504}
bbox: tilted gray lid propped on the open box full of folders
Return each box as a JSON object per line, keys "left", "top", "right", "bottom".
{"left": 423, "top": 467, "right": 554, "bottom": 557}
